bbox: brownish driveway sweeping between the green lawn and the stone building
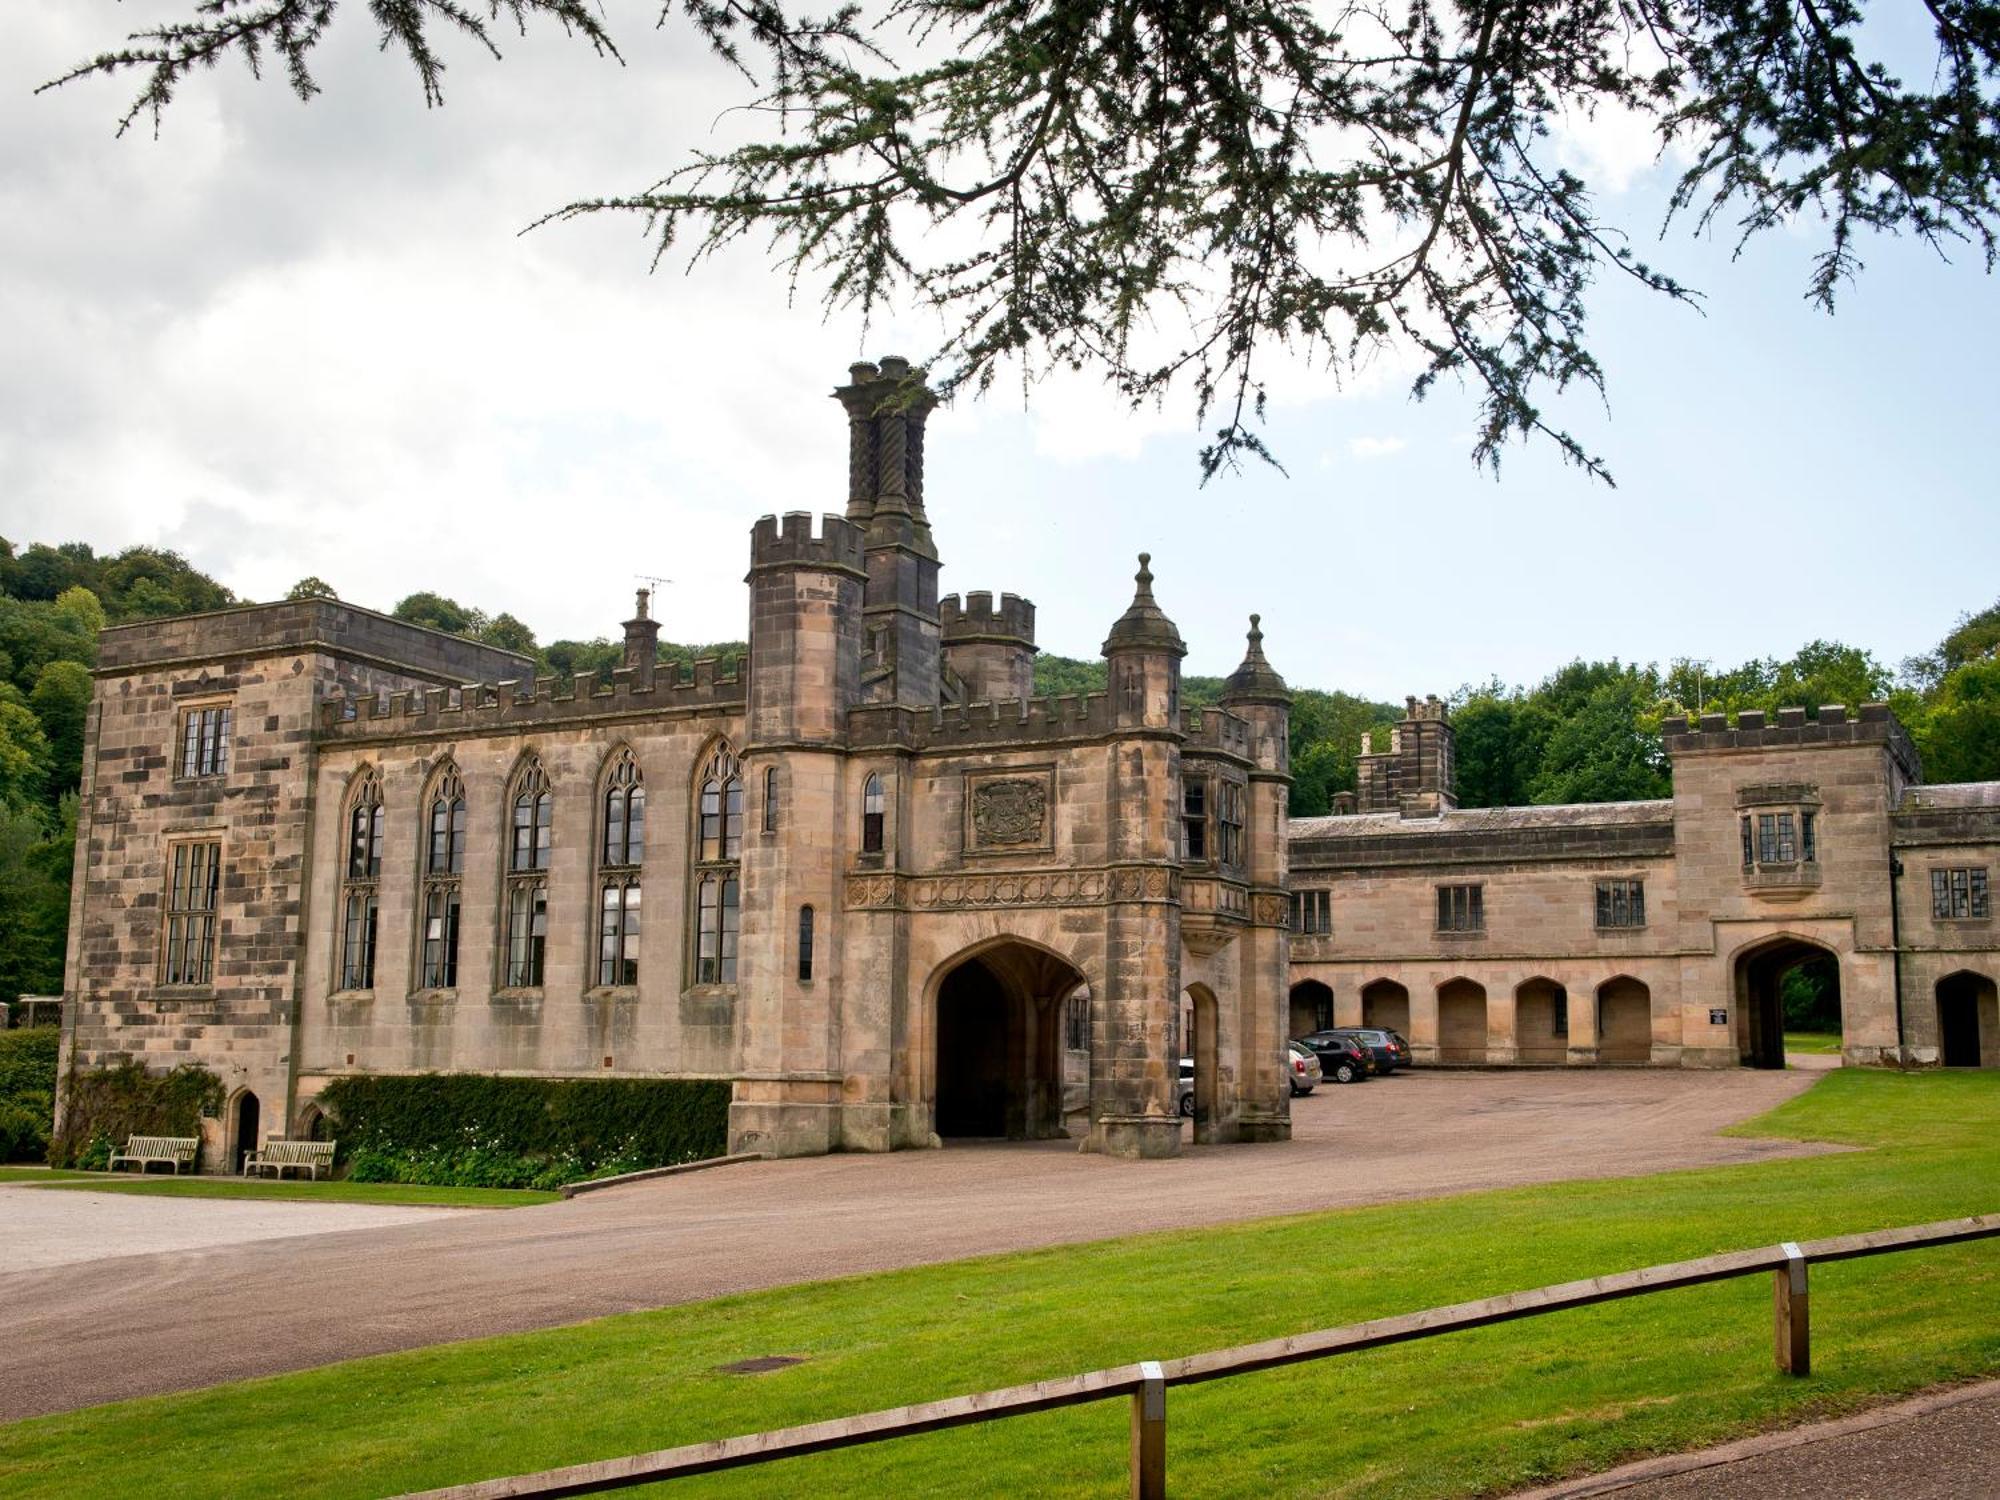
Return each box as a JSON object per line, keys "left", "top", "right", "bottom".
{"left": 0, "top": 1070, "right": 1826, "bottom": 1420}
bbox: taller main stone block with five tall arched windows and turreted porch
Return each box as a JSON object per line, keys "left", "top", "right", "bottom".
{"left": 64, "top": 360, "right": 1290, "bottom": 1162}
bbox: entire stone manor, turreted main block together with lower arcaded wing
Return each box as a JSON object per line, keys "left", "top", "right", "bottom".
{"left": 64, "top": 360, "right": 2000, "bottom": 1164}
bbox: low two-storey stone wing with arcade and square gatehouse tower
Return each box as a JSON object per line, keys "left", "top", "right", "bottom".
{"left": 1288, "top": 698, "right": 2000, "bottom": 1068}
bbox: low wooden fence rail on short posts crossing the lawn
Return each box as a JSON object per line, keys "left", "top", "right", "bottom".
{"left": 404, "top": 1214, "right": 2000, "bottom": 1500}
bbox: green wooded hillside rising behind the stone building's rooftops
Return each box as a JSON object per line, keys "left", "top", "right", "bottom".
{"left": 0, "top": 538, "right": 2000, "bottom": 1000}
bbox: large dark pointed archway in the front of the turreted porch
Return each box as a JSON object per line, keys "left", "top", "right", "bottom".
{"left": 932, "top": 938, "right": 1084, "bottom": 1140}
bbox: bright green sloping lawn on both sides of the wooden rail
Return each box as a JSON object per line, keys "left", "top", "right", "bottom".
{"left": 0, "top": 1070, "right": 2000, "bottom": 1500}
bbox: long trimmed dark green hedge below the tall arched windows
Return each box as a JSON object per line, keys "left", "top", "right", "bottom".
{"left": 318, "top": 1072, "right": 730, "bottom": 1188}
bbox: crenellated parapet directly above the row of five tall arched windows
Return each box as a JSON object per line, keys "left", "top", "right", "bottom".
{"left": 320, "top": 656, "right": 748, "bottom": 740}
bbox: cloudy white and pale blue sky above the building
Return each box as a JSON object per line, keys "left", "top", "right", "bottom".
{"left": 0, "top": 0, "right": 2000, "bottom": 700}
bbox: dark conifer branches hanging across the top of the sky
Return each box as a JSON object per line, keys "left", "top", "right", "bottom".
{"left": 50, "top": 0, "right": 2000, "bottom": 480}
